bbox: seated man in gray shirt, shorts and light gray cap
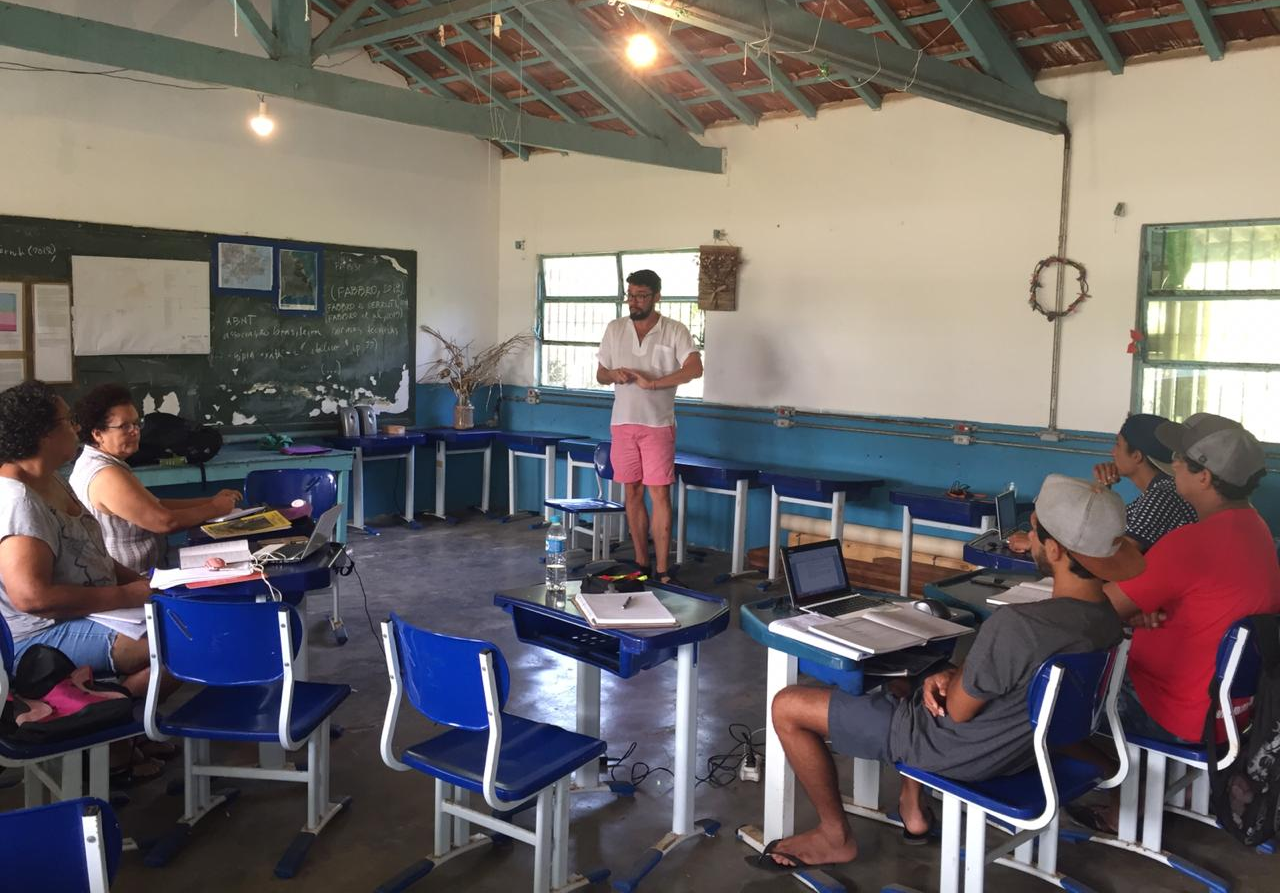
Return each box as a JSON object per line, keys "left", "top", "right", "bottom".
{"left": 749, "top": 475, "right": 1143, "bottom": 871}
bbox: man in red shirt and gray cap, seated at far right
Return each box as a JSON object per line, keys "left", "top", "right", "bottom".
{"left": 1106, "top": 412, "right": 1280, "bottom": 743}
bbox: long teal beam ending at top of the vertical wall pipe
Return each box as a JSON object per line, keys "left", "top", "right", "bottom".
{"left": 624, "top": 0, "right": 1066, "bottom": 133}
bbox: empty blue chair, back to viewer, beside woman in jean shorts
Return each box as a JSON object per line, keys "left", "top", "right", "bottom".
{"left": 143, "top": 595, "right": 351, "bottom": 878}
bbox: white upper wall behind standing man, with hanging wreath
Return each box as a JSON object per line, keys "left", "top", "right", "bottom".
{"left": 498, "top": 47, "right": 1280, "bottom": 431}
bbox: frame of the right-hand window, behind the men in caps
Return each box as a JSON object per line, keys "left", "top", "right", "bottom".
{"left": 1129, "top": 217, "right": 1280, "bottom": 442}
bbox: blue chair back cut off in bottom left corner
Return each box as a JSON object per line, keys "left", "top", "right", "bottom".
{"left": 0, "top": 797, "right": 123, "bottom": 893}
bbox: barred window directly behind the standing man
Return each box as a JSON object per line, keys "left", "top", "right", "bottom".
{"left": 536, "top": 251, "right": 707, "bottom": 399}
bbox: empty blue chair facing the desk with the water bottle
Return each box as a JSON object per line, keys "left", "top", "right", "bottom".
{"left": 378, "top": 614, "right": 608, "bottom": 893}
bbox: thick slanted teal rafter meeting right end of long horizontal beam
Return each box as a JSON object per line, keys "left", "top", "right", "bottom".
{"left": 522, "top": 0, "right": 698, "bottom": 146}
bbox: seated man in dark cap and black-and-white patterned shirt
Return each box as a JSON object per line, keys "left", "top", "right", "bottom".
{"left": 1009, "top": 412, "right": 1196, "bottom": 551}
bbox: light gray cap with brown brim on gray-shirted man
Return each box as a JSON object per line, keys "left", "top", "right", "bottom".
{"left": 1036, "top": 475, "right": 1146, "bottom": 581}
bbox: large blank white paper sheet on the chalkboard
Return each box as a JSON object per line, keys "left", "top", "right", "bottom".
{"left": 72, "top": 255, "right": 209, "bottom": 357}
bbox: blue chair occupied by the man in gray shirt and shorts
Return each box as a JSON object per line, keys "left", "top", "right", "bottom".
{"left": 883, "top": 640, "right": 1129, "bottom": 893}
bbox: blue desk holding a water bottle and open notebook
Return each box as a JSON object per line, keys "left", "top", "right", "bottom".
{"left": 494, "top": 581, "right": 730, "bottom": 890}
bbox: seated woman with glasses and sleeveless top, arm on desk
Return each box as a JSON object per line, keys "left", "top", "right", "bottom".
{"left": 70, "top": 384, "right": 241, "bottom": 573}
